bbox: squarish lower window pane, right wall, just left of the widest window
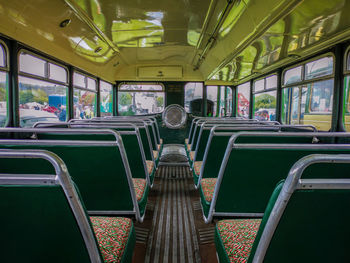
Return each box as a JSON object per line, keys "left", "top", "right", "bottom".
{"left": 254, "top": 90, "right": 277, "bottom": 121}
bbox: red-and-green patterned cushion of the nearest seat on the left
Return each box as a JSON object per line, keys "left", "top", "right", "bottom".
{"left": 90, "top": 217, "right": 132, "bottom": 263}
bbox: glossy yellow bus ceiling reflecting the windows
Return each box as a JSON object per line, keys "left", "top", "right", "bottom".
{"left": 0, "top": 0, "right": 350, "bottom": 82}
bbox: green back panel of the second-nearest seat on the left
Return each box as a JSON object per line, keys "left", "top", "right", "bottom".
{"left": 0, "top": 144, "right": 139, "bottom": 214}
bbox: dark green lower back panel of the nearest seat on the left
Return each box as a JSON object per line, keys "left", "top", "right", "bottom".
{"left": 0, "top": 187, "right": 95, "bottom": 263}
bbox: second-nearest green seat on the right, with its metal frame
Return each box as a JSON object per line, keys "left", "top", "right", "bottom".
{"left": 200, "top": 132, "right": 350, "bottom": 222}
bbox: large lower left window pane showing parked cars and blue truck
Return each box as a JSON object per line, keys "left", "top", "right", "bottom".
{"left": 19, "top": 76, "right": 67, "bottom": 127}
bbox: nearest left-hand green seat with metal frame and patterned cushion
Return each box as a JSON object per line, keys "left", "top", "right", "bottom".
{"left": 0, "top": 150, "right": 136, "bottom": 263}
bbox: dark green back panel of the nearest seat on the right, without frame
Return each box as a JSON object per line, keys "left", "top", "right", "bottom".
{"left": 248, "top": 163, "right": 350, "bottom": 263}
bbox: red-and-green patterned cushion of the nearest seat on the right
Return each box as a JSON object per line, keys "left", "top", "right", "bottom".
{"left": 216, "top": 219, "right": 261, "bottom": 263}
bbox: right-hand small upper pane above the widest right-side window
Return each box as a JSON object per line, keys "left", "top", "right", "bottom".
{"left": 305, "top": 57, "right": 333, "bottom": 79}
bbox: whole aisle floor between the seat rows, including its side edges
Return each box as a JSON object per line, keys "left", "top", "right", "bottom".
{"left": 134, "top": 166, "right": 216, "bottom": 263}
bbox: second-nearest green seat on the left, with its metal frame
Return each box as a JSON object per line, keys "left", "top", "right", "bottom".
{"left": 0, "top": 129, "right": 149, "bottom": 221}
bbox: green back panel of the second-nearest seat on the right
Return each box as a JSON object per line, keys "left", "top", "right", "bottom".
{"left": 215, "top": 147, "right": 350, "bottom": 218}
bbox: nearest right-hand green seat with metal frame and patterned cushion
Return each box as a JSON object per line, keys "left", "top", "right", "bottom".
{"left": 215, "top": 155, "right": 350, "bottom": 263}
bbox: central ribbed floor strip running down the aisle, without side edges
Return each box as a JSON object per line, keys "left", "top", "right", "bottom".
{"left": 145, "top": 166, "right": 201, "bottom": 263}
